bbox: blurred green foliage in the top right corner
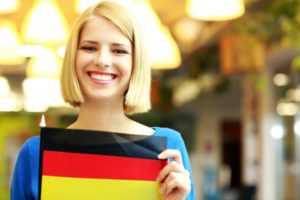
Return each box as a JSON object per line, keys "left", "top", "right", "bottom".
{"left": 233, "top": 0, "right": 300, "bottom": 48}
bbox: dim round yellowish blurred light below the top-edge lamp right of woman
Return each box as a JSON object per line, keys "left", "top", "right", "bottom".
{"left": 173, "top": 18, "right": 202, "bottom": 50}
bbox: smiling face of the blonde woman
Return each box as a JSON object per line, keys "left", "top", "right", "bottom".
{"left": 76, "top": 16, "right": 132, "bottom": 101}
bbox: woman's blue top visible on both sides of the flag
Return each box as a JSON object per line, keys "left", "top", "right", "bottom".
{"left": 10, "top": 127, "right": 195, "bottom": 200}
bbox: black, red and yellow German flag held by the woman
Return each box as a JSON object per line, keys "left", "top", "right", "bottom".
{"left": 39, "top": 128, "right": 166, "bottom": 200}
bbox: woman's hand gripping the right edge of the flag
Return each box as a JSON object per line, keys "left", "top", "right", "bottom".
{"left": 156, "top": 149, "right": 191, "bottom": 200}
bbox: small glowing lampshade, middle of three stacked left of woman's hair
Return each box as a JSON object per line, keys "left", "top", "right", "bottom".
{"left": 26, "top": 49, "right": 61, "bottom": 78}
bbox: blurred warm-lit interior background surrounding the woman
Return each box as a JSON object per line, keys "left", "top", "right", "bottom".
{"left": 0, "top": 0, "right": 300, "bottom": 200}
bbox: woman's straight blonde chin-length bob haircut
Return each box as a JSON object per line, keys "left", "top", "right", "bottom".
{"left": 60, "top": 1, "right": 151, "bottom": 114}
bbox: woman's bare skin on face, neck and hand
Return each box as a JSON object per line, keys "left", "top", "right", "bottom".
{"left": 68, "top": 17, "right": 190, "bottom": 200}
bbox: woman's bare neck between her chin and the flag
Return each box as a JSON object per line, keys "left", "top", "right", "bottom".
{"left": 69, "top": 97, "right": 130, "bottom": 132}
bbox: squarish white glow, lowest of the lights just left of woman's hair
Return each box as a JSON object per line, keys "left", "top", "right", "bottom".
{"left": 23, "top": 78, "right": 64, "bottom": 112}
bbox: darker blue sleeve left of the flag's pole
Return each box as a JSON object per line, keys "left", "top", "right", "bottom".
{"left": 10, "top": 141, "right": 30, "bottom": 200}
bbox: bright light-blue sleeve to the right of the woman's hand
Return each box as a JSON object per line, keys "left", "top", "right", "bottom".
{"left": 173, "top": 132, "right": 195, "bottom": 200}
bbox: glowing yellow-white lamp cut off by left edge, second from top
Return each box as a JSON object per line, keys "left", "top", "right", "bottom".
{"left": 0, "top": 21, "right": 25, "bottom": 65}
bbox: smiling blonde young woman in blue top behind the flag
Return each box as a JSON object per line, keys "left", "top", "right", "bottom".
{"left": 11, "top": 2, "right": 194, "bottom": 200}
